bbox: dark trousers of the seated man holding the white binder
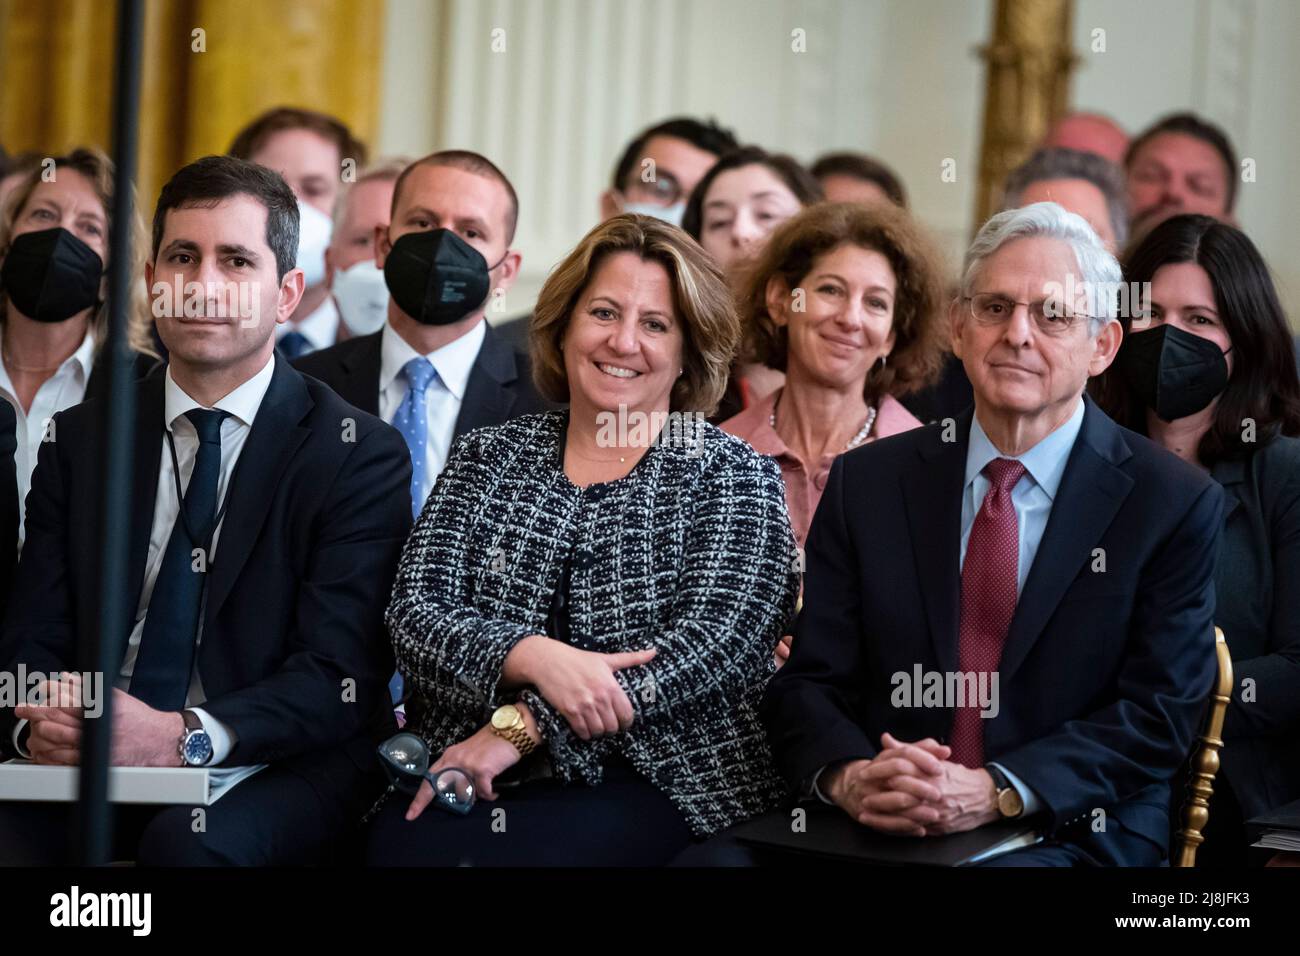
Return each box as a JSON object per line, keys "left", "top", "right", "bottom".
{"left": 0, "top": 750, "right": 385, "bottom": 866}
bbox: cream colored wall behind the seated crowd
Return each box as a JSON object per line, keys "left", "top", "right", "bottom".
{"left": 380, "top": 0, "right": 1300, "bottom": 317}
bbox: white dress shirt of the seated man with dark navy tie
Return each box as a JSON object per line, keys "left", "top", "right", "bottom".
{"left": 14, "top": 355, "right": 276, "bottom": 800}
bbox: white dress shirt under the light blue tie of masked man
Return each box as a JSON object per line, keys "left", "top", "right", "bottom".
{"left": 380, "top": 320, "right": 488, "bottom": 512}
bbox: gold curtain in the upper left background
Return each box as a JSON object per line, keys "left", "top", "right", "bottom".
{"left": 0, "top": 0, "right": 385, "bottom": 219}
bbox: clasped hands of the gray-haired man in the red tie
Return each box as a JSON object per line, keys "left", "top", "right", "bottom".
{"left": 818, "top": 734, "right": 1000, "bottom": 836}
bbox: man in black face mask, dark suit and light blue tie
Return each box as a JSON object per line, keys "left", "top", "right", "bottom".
{"left": 295, "top": 150, "right": 546, "bottom": 515}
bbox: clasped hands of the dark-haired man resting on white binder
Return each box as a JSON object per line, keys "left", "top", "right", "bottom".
{"left": 14, "top": 675, "right": 185, "bottom": 767}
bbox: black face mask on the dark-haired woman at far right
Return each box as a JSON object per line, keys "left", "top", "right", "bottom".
{"left": 1119, "top": 325, "right": 1231, "bottom": 421}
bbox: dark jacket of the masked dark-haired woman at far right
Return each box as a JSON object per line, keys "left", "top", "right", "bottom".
{"left": 1210, "top": 437, "right": 1300, "bottom": 819}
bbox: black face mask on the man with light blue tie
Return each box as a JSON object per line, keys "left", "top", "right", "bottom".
{"left": 384, "top": 229, "right": 504, "bottom": 325}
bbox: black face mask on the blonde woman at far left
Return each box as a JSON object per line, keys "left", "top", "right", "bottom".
{"left": 0, "top": 228, "right": 104, "bottom": 323}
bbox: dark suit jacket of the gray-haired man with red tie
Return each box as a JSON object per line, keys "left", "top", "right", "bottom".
{"left": 763, "top": 399, "right": 1223, "bottom": 860}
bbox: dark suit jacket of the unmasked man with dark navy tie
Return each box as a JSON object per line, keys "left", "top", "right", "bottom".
{"left": 0, "top": 358, "right": 411, "bottom": 787}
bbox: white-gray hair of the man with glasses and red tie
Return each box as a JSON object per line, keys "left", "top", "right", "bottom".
{"left": 962, "top": 203, "right": 1123, "bottom": 336}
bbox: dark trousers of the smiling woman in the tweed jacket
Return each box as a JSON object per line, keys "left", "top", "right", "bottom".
{"left": 365, "top": 760, "right": 692, "bottom": 866}
